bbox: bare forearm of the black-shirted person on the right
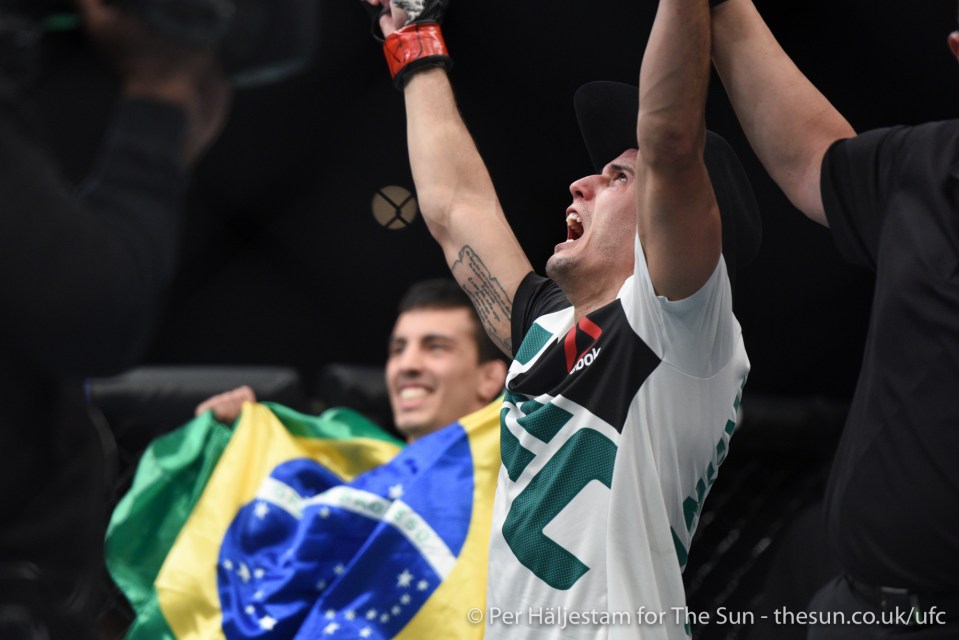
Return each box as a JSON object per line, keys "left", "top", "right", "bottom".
{"left": 712, "top": 0, "right": 856, "bottom": 226}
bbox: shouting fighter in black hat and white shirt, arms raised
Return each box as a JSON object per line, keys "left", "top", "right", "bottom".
{"left": 370, "top": 0, "right": 754, "bottom": 638}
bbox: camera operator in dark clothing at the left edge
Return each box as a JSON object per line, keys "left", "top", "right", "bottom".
{"left": 0, "top": 0, "right": 230, "bottom": 640}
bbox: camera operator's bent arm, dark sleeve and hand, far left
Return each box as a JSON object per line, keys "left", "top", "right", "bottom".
{"left": 0, "top": 0, "right": 230, "bottom": 377}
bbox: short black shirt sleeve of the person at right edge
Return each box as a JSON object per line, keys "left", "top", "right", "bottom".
{"left": 820, "top": 127, "right": 905, "bottom": 271}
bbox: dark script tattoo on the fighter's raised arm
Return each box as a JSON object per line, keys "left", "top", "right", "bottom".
{"left": 450, "top": 245, "right": 513, "bottom": 355}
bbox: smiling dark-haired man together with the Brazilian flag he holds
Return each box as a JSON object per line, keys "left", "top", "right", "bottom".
{"left": 132, "top": 279, "right": 506, "bottom": 640}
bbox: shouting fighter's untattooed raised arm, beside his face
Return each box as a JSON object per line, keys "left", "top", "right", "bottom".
{"left": 636, "top": 0, "right": 722, "bottom": 299}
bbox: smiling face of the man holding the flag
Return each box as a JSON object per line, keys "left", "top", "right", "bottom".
{"left": 386, "top": 308, "right": 502, "bottom": 442}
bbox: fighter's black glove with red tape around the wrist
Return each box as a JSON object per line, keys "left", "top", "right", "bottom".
{"left": 377, "top": 0, "right": 453, "bottom": 91}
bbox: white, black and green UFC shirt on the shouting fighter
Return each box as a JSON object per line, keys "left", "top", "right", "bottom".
{"left": 486, "top": 239, "right": 749, "bottom": 638}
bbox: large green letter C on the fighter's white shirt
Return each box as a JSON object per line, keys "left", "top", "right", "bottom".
{"left": 503, "top": 427, "right": 616, "bottom": 590}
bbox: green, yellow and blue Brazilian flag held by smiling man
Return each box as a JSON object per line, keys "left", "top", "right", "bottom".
{"left": 106, "top": 402, "right": 500, "bottom": 640}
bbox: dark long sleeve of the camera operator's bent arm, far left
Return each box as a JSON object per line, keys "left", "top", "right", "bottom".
{"left": 0, "top": 95, "right": 186, "bottom": 376}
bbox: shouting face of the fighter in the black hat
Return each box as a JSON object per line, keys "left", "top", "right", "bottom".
{"left": 546, "top": 149, "right": 636, "bottom": 290}
